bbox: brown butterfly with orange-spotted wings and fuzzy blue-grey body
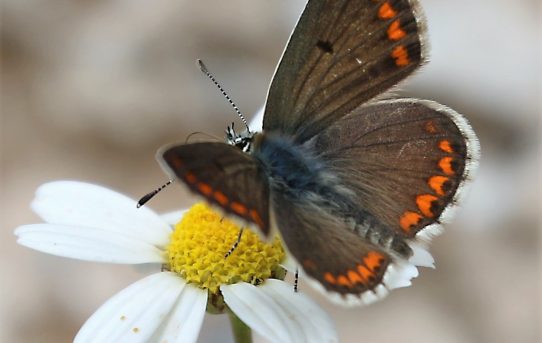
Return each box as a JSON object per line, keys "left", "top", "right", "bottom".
{"left": 158, "top": 0, "right": 479, "bottom": 305}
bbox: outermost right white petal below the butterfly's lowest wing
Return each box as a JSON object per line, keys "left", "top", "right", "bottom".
{"left": 259, "top": 279, "right": 339, "bottom": 343}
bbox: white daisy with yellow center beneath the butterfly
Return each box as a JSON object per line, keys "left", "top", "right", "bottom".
{"left": 15, "top": 181, "right": 338, "bottom": 343}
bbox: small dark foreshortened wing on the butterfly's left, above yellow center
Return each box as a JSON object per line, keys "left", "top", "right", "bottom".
{"left": 159, "top": 143, "right": 269, "bottom": 235}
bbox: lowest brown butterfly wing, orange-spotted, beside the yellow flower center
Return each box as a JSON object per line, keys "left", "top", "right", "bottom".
{"left": 272, "top": 192, "right": 417, "bottom": 305}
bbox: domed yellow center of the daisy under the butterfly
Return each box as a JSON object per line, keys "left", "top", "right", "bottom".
{"left": 167, "top": 203, "right": 284, "bottom": 294}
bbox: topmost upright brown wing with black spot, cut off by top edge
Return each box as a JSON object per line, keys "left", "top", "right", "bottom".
{"left": 264, "top": 0, "right": 423, "bottom": 143}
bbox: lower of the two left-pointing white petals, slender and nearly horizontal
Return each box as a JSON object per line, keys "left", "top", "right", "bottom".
{"left": 15, "top": 224, "right": 164, "bottom": 264}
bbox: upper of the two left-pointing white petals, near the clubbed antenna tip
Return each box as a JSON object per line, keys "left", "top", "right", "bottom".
{"left": 32, "top": 181, "right": 171, "bottom": 247}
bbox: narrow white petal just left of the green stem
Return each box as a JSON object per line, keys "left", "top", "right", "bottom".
{"left": 150, "top": 284, "right": 207, "bottom": 343}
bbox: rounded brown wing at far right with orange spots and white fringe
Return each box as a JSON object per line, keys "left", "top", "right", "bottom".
{"left": 314, "top": 99, "right": 479, "bottom": 238}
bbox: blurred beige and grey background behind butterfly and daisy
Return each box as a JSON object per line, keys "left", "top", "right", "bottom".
{"left": 0, "top": 0, "right": 542, "bottom": 342}
